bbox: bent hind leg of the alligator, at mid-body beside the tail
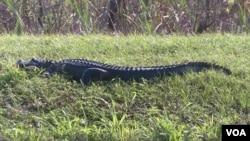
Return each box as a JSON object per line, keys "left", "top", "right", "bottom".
{"left": 81, "top": 68, "right": 110, "bottom": 85}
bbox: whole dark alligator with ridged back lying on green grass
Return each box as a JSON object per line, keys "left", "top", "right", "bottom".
{"left": 16, "top": 58, "right": 231, "bottom": 84}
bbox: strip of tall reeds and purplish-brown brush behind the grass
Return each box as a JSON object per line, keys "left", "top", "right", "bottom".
{"left": 0, "top": 0, "right": 250, "bottom": 34}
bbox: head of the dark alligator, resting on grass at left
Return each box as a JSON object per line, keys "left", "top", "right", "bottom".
{"left": 16, "top": 58, "right": 53, "bottom": 68}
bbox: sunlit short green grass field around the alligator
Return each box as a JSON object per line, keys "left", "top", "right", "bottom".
{"left": 0, "top": 34, "right": 250, "bottom": 141}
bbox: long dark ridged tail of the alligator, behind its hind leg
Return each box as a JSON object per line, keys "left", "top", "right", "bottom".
{"left": 105, "top": 62, "right": 231, "bottom": 81}
